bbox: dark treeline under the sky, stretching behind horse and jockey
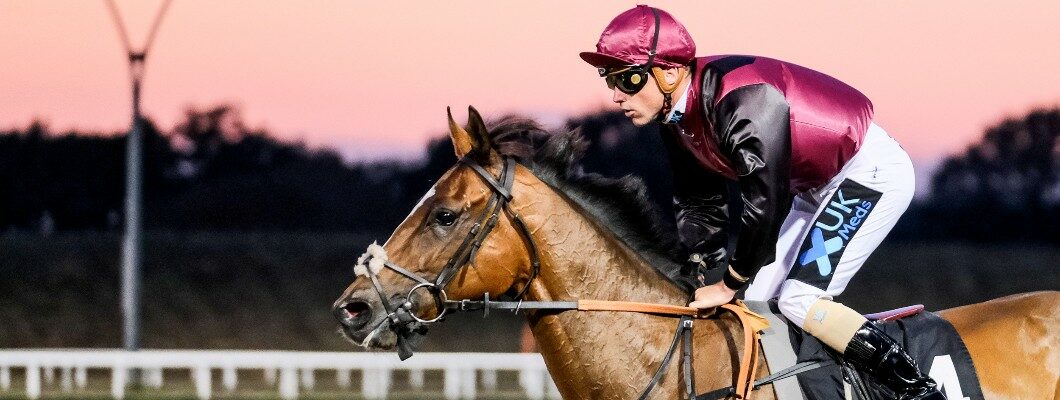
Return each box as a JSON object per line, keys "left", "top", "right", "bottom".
{"left": 0, "top": 106, "right": 1060, "bottom": 244}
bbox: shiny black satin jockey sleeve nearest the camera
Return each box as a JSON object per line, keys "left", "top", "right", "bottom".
{"left": 713, "top": 84, "right": 791, "bottom": 289}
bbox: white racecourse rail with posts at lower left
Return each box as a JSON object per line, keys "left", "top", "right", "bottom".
{"left": 0, "top": 349, "right": 560, "bottom": 400}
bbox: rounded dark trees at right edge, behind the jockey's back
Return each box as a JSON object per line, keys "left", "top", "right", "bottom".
{"left": 926, "top": 108, "right": 1060, "bottom": 243}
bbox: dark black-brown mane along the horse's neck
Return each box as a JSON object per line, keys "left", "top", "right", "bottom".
{"left": 489, "top": 116, "right": 688, "bottom": 290}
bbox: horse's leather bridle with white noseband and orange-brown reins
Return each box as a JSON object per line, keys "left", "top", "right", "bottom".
{"left": 354, "top": 157, "right": 805, "bottom": 400}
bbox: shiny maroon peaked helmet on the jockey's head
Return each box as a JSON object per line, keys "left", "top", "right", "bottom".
{"left": 580, "top": 4, "right": 695, "bottom": 68}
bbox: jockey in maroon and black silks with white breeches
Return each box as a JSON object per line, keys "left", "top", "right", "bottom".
{"left": 581, "top": 5, "right": 946, "bottom": 400}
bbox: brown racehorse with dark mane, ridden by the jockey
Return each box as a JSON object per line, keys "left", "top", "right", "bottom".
{"left": 333, "top": 107, "right": 1060, "bottom": 399}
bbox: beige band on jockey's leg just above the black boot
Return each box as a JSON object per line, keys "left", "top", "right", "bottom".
{"left": 802, "top": 298, "right": 868, "bottom": 353}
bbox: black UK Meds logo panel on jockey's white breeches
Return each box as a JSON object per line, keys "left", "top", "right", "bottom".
{"left": 789, "top": 179, "right": 882, "bottom": 289}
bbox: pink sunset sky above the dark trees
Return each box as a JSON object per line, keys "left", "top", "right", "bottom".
{"left": 0, "top": 0, "right": 1060, "bottom": 174}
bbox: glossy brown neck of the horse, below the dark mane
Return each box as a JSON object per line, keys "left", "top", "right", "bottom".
{"left": 520, "top": 182, "right": 741, "bottom": 399}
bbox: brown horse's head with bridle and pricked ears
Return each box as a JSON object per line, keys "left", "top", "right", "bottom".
{"left": 333, "top": 108, "right": 536, "bottom": 349}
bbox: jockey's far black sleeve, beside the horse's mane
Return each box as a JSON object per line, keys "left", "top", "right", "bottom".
{"left": 663, "top": 127, "right": 729, "bottom": 280}
